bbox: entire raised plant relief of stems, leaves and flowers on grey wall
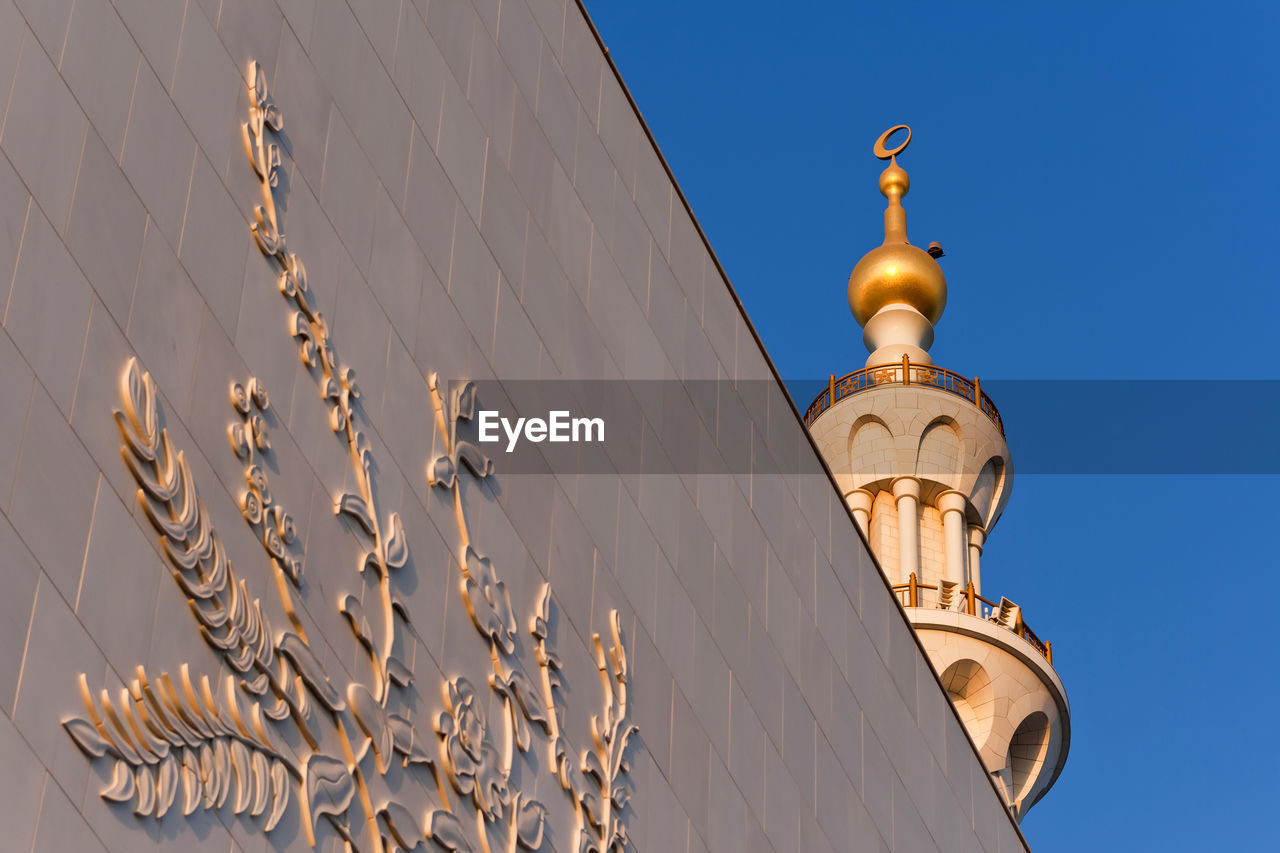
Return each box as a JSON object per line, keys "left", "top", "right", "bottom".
{"left": 63, "top": 63, "right": 636, "bottom": 853}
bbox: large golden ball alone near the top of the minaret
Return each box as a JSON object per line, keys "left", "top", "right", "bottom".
{"left": 849, "top": 245, "right": 947, "bottom": 325}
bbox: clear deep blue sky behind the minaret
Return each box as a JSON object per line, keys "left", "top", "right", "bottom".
{"left": 588, "top": 0, "right": 1280, "bottom": 853}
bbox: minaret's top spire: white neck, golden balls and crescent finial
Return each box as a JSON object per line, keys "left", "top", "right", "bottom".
{"left": 849, "top": 124, "right": 947, "bottom": 366}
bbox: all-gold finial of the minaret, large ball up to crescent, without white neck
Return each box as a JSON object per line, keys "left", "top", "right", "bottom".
{"left": 849, "top": 124, "right": 947, "bottom": 325}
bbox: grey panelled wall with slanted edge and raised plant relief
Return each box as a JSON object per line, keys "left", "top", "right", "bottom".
{"left": 0, "top": 0, "right": 1025, "bottom": 853}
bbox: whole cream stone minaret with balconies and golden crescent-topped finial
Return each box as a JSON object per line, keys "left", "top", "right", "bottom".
{"left": 805, "top": 124, "right": 1071, "bottom": 818}
